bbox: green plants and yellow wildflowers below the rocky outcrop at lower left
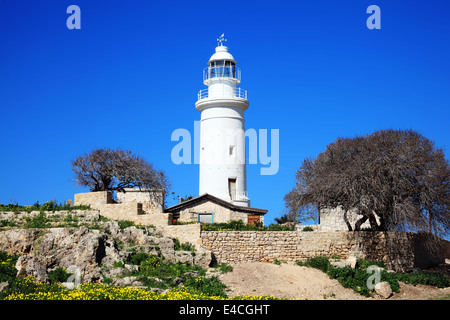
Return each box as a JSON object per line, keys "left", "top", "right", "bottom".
{"left": 0, "top": 252, "right": 243, "bottom": 300}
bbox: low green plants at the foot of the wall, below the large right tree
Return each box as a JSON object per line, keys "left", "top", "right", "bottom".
{"left": 297, "top": 256, "right": 450, "bottom": 297}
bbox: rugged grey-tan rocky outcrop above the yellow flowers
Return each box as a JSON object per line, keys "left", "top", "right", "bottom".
{"left": 0, "top": 214, "right": 211, "bottom": 285}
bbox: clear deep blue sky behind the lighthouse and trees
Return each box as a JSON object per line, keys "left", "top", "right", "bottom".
{"left": 0, "top": 0, "right": 450, "bottom": 224}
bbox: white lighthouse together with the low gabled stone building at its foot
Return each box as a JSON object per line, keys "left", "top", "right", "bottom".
{"left": 164, "top": 35, "right": 267, "bottom": 224}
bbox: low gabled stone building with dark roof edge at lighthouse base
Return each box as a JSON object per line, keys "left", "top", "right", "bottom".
{"left": 164, "top": 193, "right": 267, "bottom": 224}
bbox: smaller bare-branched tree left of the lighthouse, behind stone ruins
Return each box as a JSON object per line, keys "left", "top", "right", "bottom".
{"left": 72, "top": 148, "right": 169, "bottom": 192}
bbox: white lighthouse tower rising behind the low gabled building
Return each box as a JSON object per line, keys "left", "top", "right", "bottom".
{"left": 195, "top": 35, "right": 250, "bottom": 207}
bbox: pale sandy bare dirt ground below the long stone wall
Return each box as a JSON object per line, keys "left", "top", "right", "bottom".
{"left": 220, "top": 262, "right": 450, "bottom": 300}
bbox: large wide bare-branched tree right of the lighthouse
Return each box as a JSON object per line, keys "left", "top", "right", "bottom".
{"left": 285, "top": 130, "right": 450, "bottom": 235}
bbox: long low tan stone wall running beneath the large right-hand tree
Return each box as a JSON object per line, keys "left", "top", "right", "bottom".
{"left": 201, "top": 231, "right": 450, "bottom": 271}
